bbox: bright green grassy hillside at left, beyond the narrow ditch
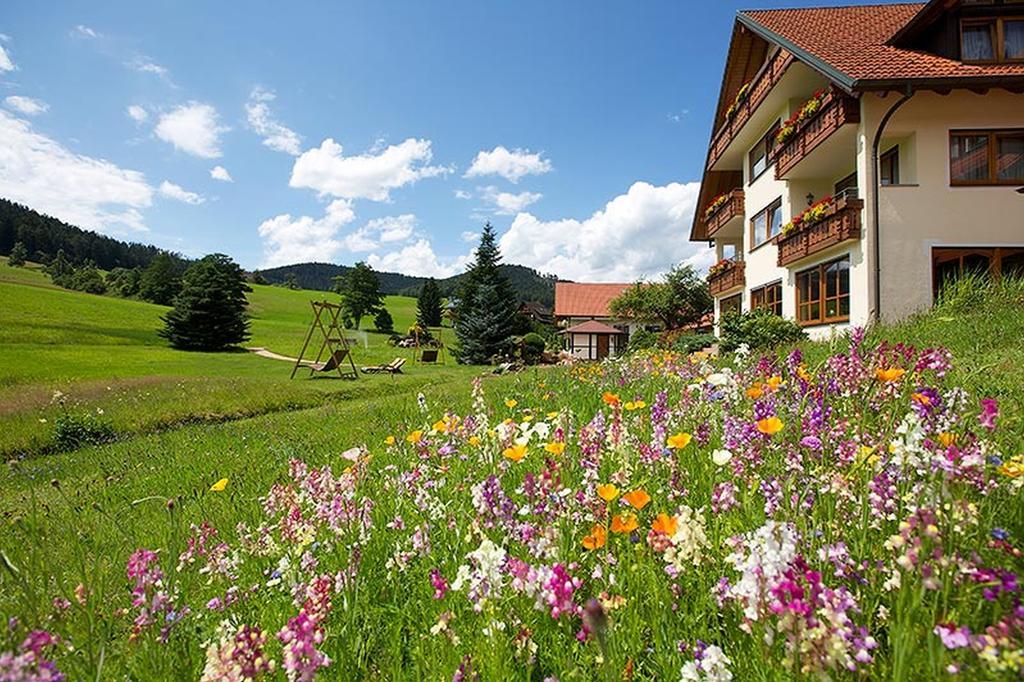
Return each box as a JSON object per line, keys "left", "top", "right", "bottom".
{"left": 0, "top": 261, "right": 464, "bottom": 456}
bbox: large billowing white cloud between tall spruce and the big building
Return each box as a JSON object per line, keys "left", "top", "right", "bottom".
{"left": 500, "top": 182, "right": 714, "bottom": 282}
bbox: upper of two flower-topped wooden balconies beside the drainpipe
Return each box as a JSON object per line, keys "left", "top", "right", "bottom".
{"left": 773, "top": 88, "right": 860, "bottom": 180}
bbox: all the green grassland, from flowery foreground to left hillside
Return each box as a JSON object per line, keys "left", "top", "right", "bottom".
{"left": 0, "top": 266, "right": 1024, "bottom": 682}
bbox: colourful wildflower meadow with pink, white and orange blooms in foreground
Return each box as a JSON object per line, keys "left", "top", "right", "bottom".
{"left": 0, "top": 332, "right": 1024, "bottom": 682}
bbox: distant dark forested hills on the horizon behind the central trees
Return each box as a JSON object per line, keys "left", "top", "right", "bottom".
{"left": 260, "top": 263, "right": 556, "bottom": 307}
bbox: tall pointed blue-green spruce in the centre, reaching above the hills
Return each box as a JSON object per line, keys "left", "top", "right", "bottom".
{"left": 456, "top": 222, "right": 516, "bottom": 365}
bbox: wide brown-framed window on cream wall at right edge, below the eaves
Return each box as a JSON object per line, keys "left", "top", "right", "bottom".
{"left": 949, "top": 129, "right": 1024, "bottom": 185}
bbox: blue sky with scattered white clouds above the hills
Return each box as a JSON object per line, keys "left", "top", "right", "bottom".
{"left": 0, "top": 0, "right": 897, "bottom": 281}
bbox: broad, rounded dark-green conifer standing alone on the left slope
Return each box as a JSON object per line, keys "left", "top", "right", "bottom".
{"left": 158, "top": 253, "right": 252, "bottom": 350}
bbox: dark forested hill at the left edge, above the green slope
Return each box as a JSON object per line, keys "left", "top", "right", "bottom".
{"left": 0, "top": 199, "right": 182, "bottom": 270}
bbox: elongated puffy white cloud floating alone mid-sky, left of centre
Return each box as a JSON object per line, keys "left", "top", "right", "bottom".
{"left": 289, "top": 137, "right": 449, "bottom": 202}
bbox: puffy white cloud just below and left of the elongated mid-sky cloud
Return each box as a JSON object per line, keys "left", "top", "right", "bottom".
{"left": 258, "top": 199, "right": 355, "bottom": 267}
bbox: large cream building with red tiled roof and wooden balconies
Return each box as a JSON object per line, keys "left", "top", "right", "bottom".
{"left": 690, "top": 0, "right": 1024, "bottom": 336}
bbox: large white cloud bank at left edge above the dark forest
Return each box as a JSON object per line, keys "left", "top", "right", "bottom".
{"left": 0, "top": 111, "right": 153, "bottom": 235}
